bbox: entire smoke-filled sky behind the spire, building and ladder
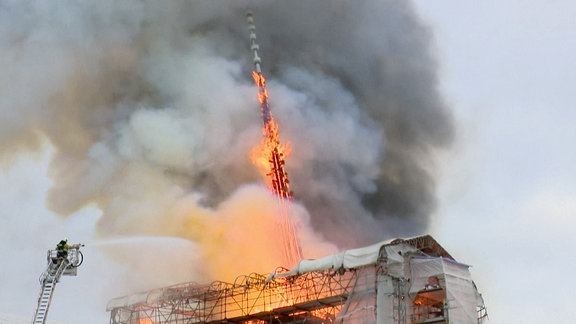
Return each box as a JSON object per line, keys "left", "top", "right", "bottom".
{"left": 0, "top": 0, "right": 574, "bottom": 323}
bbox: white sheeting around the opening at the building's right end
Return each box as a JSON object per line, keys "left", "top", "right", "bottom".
{"left": 409, "top": 257, "right": 478, "bottom": 324}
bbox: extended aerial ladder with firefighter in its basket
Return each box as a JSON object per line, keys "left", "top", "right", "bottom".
{"left": 32, "top": 244, "right": 84, "bottom": 324}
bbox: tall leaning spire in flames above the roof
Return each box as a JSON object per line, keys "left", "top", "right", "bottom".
{"left": 246, "top": 12, "right": 302, "bottom": 266}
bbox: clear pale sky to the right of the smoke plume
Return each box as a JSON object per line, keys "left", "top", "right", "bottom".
{"left": 415, "top": 1, "right": 576, "bottom": 323}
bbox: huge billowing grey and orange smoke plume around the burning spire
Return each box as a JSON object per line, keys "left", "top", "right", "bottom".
{"left": 0, "top": 0, "right": 453, "bottom": 272}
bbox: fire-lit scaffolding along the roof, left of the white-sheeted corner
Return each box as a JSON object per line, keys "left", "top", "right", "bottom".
{"left": 108, "top": 268, "right": 356, "bottom": 323}
